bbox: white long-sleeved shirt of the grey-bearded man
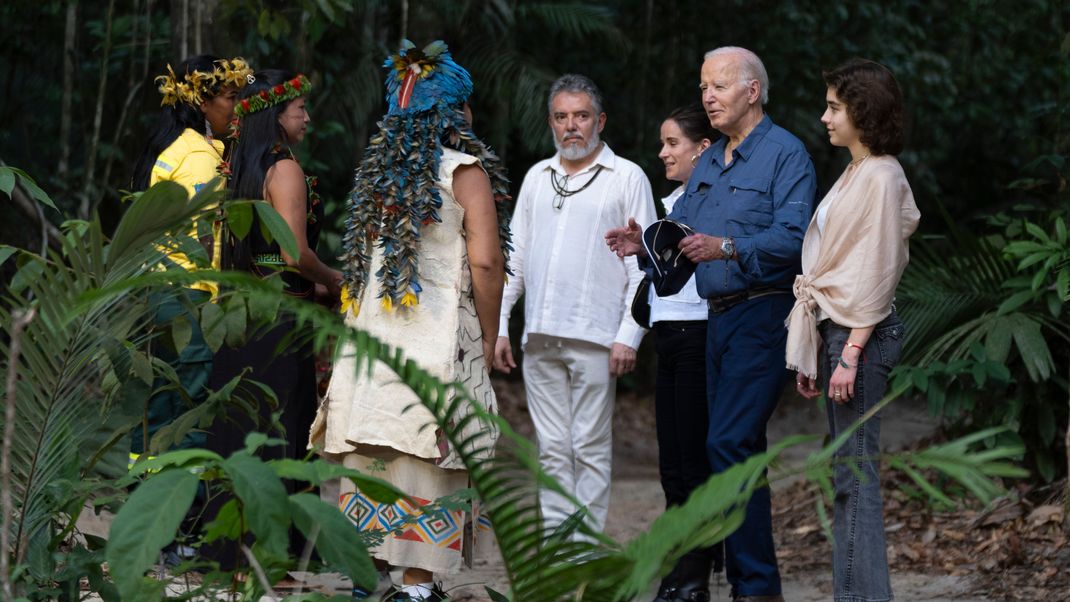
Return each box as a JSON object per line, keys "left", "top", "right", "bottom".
{"left": 499, "top": 144, "right": 657, "bottom": 349}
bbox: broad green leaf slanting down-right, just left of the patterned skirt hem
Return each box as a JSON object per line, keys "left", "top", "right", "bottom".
{"left": 290, "top": 493, "right": 379, "bottom": 591}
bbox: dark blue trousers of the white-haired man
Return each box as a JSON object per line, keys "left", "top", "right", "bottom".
{"left": 706, "top": 293, "right": 795, "bottom": 596}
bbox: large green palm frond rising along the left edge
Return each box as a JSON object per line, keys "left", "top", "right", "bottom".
{"left": 0, "top": 184, "right": 219, "bottom": 562}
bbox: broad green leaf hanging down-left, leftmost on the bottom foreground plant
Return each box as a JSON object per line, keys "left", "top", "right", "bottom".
{"left": 107, "top": 469, "right": 197, "bottom": 600}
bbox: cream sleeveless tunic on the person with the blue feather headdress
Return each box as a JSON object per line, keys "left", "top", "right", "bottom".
{"left": 311, "top": 149, "right": 498, "bottom": 468}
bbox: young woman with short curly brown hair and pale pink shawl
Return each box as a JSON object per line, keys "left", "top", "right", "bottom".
{"left": 786, "top": 59, "right": 919, "bottom": 602}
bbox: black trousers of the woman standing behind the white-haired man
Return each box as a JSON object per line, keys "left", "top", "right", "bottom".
{"left": 654, "top": 320, "right": 724, "bottom": 581}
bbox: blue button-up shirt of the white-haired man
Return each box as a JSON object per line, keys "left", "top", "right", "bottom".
{"left": 669, "top": 115, "right": 816, "bottom": 298}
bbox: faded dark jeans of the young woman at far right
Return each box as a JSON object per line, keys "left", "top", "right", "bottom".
{"left": 821, "top": 311, "right": 904, "bottom": 602}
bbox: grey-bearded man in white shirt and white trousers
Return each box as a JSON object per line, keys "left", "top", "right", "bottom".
{"left": 494, "top": 74, "right": 657, "bottom": 530}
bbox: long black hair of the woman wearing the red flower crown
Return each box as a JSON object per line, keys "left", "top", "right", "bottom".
{"left": 221, "top": 70, "right": 296, "bottom": 271}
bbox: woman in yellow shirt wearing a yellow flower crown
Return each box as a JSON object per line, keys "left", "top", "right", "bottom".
{"left": 131, "top": 55, "right": 253, "bottom": 454}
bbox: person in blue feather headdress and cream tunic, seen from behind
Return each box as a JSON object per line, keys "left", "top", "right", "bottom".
{"left": 311, "top": 41, "right": 509, "bottom": 600}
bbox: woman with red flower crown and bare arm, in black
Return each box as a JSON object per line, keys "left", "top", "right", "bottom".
{"left": 205, "top": 70, "right": 341, "bottom": 569}
